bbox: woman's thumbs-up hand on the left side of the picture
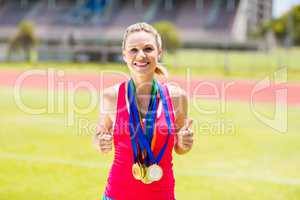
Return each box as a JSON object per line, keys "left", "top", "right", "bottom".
{"left": 94, "top": 126, "right": 113, "bottom": 153}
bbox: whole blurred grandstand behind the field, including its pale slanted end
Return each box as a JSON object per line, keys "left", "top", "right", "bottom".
{"left": 0, "top": 0, "right": 272, "bottom": 60}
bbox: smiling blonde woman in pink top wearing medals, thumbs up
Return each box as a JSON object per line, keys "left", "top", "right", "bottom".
{"left": 94, "top": 23, "right": 193, "bottom": 200}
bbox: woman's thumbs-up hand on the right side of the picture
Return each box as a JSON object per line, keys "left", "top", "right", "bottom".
{"left": 177, "top": 119, "right": 194, "bottom": 153}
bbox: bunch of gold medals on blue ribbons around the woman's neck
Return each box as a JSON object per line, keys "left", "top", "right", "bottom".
{"left": 127, "top": 80, "right": 171, "bottom": 184}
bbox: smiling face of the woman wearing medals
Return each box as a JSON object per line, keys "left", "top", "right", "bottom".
{"left": 123, "top": 31, "right": 161, "bottom": 76}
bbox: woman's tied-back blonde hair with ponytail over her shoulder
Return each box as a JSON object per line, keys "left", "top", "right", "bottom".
{"left": 122, "top": 22, "right": 168, "bottom": 78}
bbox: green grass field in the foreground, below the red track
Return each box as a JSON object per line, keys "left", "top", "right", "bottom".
{"left": 0, "top": 83, "right": 300, "bottom": 200}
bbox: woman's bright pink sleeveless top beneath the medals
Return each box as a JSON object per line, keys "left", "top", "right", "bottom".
{"left": 105, "top": 82, "right": 175, "bottom": 200}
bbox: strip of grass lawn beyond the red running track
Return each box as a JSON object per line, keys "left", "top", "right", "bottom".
{"left": 0, "top": 48, "right": 300, "bottom": 81}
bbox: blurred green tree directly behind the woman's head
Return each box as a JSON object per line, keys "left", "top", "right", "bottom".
{"left": 153, "top": 21, "right": 181, "bottom": 53}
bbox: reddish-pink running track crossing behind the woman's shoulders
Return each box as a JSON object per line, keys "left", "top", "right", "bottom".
{"left": 0, "top": 69, "right": 300, "bottom": 105}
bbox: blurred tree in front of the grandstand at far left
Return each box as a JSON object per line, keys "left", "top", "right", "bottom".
{"left": 8, "top": 20, "right": 38, "bottom": 62}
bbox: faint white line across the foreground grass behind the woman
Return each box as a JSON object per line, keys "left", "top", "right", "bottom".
{"left": 0, "top": 153, "right": 300, "bottom": 185}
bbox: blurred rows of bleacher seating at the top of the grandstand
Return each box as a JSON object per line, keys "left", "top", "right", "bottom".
{"left": 0, "top": 0, "right": 244, "bottom": 44}
